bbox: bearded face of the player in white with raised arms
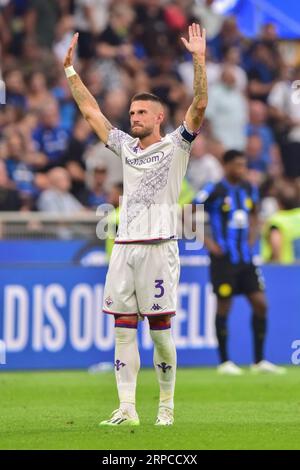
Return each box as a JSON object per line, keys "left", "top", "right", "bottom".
{"left": 129, "top": 101, "right": 163, "bottom": 139}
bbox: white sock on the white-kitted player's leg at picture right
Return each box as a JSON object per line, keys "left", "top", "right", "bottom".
{"left": 150, "top": 328, "right": 176, "bottom": 410}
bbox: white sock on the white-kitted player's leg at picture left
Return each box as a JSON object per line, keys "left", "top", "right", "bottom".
{"left": 115, "top": 327, "right": 140, "bottom": 414}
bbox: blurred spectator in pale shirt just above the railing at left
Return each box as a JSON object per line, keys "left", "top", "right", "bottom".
{"left": 37, "top": 167, "right": 84, "bottom": 215}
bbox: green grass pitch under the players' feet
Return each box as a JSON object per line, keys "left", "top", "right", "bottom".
{"left": 0, "top": 367, "right": 300, "bottom": 450}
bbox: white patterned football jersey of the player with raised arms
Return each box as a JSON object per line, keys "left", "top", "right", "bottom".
{"left": 107, "top": 125, "right": 195, "bottom": 243}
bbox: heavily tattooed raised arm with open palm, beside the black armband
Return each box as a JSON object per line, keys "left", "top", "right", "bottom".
{"left": 181, "top": 23, "right": 207, "bottom": 132}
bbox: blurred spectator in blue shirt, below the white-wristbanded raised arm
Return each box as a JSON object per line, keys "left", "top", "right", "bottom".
{"left": 33, "top": 101, "right": 69, "bottom": 169}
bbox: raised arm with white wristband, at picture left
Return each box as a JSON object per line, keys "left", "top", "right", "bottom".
{"left": 64, "top": 33, "right": 113, "bottom": 144}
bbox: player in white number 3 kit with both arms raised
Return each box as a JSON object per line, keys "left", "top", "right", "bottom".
{"left": 64, "top": 23, "right": 207, "bottom": 426}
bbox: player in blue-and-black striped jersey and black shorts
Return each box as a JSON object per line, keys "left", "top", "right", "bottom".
{"left": 194, "top": 150, "right": 285, "bottom": 375}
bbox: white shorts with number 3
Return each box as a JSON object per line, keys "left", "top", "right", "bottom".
{"left": 103, "top": 241, "right": 180, "bottom": 317}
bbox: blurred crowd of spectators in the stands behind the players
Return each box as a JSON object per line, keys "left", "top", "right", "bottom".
{"left": 0, "top": 0, "right": 300, "bottom": 228}
